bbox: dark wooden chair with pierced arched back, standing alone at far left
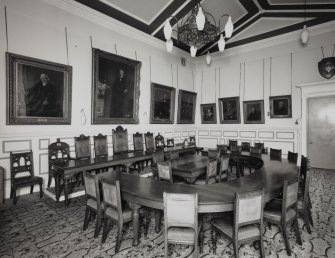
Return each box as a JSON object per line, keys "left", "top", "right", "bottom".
{"left": 10, "top": 151, "right": 43, "bottom": 204}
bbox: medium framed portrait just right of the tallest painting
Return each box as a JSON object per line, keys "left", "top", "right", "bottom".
{"left": 150, "top": 83, "right": 176, "bottom": 124}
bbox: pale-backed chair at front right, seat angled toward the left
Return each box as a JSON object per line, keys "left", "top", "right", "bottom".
{"left": 210, "top": 188, "right": 265, "bottom": 257}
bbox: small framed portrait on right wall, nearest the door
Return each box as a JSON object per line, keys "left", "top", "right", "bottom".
{"left": 270, "top": 95, "right": 292, "bottom": 118}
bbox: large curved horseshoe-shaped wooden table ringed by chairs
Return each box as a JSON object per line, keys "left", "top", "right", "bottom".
{"left": 105, "top": 155, "right": 298, "bottom": 246}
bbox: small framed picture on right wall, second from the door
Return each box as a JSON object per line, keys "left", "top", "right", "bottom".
{"left": 243, "top": 100, "right": 264, "bottom": 124}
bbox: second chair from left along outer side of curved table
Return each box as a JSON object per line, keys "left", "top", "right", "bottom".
{"left": 101, "top": 179, "right": 148, "bottom": 253}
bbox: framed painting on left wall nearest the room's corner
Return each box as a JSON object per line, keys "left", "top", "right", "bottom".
{"left": 177, "top": 90, "right": 197, "bottom": 124}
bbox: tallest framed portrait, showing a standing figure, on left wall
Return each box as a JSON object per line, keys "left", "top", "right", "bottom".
{"left": 92, "top": 48, "right": 142, "bottom": 124}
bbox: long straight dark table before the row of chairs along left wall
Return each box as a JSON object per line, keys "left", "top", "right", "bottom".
{"left": 53, "top": 146, "right": 201, "bottom": 206}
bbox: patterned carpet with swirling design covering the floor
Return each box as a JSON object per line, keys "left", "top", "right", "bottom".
{"left": 0, "top": 169, "right": 335, "bottom": 258}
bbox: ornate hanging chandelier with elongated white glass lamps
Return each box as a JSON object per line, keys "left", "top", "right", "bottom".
{"left": 164, "top": 1, "right": 234, "bottom": 64}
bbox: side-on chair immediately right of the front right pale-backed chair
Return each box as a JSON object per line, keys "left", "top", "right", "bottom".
{"left": 264, "top": 179, "right": 302, "bottom": 255}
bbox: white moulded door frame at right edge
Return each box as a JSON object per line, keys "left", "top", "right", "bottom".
{"left": 296, "top": 80, "right": 335, "bottom": 156}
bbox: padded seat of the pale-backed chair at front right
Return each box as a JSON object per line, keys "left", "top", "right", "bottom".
{"left": 211, "top": 213, "right": 260, "bottom": 241}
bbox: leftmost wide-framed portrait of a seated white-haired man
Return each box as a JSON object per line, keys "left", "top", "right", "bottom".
{"left": 6, "top": 52, "right": 72, "bottom": 125}
